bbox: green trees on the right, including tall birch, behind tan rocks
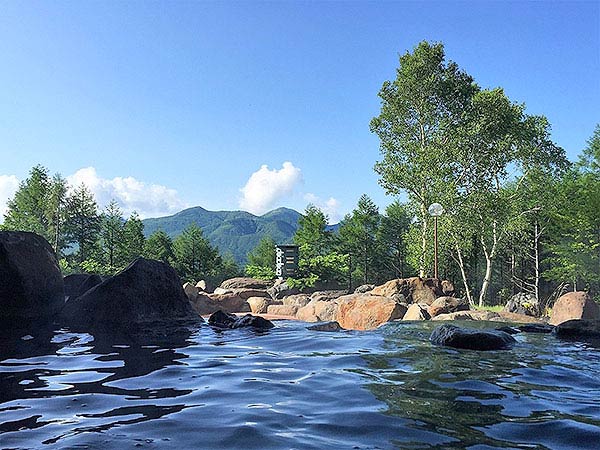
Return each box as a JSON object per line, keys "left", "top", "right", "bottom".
{"left": 246, "top": 42, "right": 600, "bottom": 305}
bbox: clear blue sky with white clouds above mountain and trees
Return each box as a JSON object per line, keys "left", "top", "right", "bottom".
{"left": 0, "top": 0, "right": 600, "bottom": 221}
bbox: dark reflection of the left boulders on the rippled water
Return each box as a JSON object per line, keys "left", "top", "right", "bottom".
{"left": 0, "top": 324, "right": 197, "bottom": 448}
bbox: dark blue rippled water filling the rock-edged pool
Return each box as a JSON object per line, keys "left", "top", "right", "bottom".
{"left": 0, "top": 322, "right": 600, "bottom": 450}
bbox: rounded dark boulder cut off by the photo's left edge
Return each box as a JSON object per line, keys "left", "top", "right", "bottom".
{"left": 0, "top": 231, "right": 65, "bottom": 320}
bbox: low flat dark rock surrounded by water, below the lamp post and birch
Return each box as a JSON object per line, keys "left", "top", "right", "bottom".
{"left": 429, "top": 324, "right": 516, "bottom": 350}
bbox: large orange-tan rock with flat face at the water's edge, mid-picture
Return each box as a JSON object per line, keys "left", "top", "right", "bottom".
{"left": 336, "top": 294, "right": 406, "bottom": 330}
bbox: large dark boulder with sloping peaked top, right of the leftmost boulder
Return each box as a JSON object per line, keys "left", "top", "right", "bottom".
{"left": 62, "top": 258, "right": 201, "bottom": 328}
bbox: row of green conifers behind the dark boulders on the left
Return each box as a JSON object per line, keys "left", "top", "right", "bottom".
{"left": 0, "top": 165, "right": 240, "bottom": 283}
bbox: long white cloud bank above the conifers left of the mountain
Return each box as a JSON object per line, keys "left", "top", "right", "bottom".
{"left": 67, "top": 167, "right": 187, "bottom": 218}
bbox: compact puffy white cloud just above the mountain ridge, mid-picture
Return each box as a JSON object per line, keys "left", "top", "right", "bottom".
{"left": 239, "top": 161, "right": 302, "bottom": 214}
